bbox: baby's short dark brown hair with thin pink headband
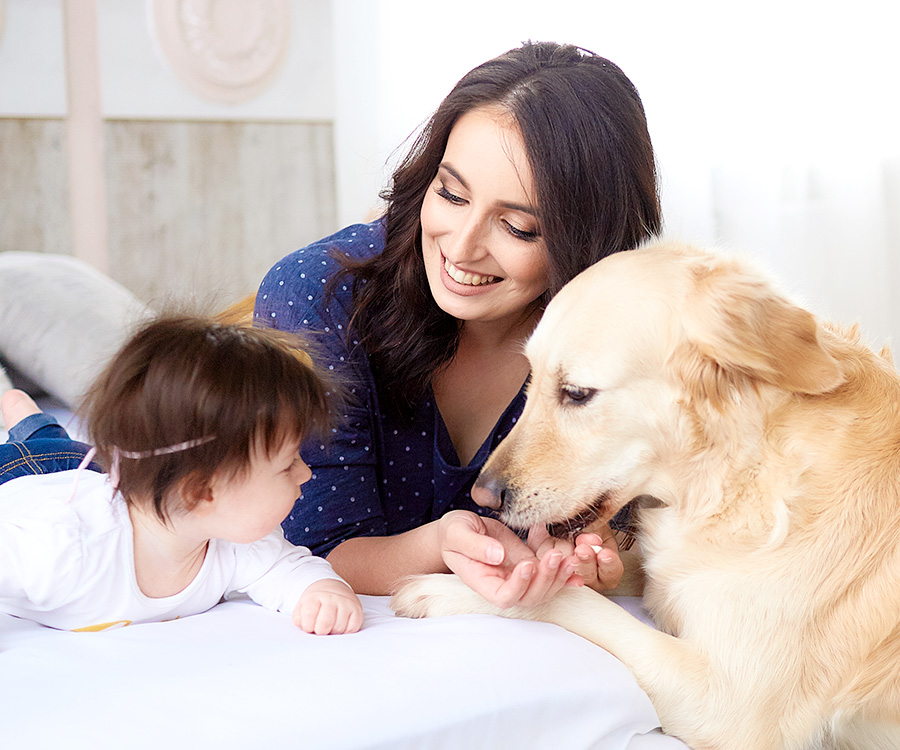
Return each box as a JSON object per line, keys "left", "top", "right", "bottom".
{"left": 79, "top": 316, "right": 333, "bottom": 521}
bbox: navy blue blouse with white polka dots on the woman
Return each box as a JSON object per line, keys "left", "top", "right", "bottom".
{"left": 254, "top": 222, "right": 525, "bottom": 555}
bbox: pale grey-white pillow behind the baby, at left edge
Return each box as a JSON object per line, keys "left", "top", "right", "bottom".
{"left": 0, "top": 252, "right": 151, "bottom": 406}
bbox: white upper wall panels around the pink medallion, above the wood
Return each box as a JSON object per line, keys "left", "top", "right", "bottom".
{"left": 0, "top": 0, "right": 334, "bottom": 121}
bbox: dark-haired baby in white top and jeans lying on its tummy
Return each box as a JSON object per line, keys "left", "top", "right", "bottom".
{"left": 0, "top": 317, "right": 363, "bottom": 635}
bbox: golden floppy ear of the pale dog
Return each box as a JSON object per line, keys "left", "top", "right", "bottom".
{"left": 681, "top": 261, "right": 844, "bottom": 401}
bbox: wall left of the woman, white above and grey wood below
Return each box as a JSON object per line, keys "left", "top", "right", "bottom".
{"left": 0, "top": 0, "right": 337, "bottom": 306}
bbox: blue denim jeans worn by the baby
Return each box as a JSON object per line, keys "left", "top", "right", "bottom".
{"left": 0, "top": 413, "right": 103, "bottom": 484}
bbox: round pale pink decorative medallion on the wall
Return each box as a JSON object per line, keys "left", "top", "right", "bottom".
{"left": 147, "top": 0, "right": 290, "bottom": 104}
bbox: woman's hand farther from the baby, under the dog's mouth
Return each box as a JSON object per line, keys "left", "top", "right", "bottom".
{"left": 528, "top": 521, "right": 625, "bottom": 593}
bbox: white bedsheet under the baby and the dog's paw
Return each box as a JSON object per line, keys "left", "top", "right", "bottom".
{"left": 0, "top": 597, "right": 685, "bottom": 750}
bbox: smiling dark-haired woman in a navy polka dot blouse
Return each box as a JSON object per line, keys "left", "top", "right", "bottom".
{"left": 254, "top": 43, "right": 661, "bottom": 606}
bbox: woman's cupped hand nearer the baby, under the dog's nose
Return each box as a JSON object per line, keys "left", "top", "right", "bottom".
{"left": 438, "top": 510, "right": 582, "bottom": 609}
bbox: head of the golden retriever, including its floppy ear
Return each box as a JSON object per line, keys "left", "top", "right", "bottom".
{"left": 472, "top": 243, "right": 843, "bottom": 535}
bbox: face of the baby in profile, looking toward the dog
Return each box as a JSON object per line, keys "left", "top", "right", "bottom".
{"left": 202, "top": 440, "right": 312, "bottom": 544}
